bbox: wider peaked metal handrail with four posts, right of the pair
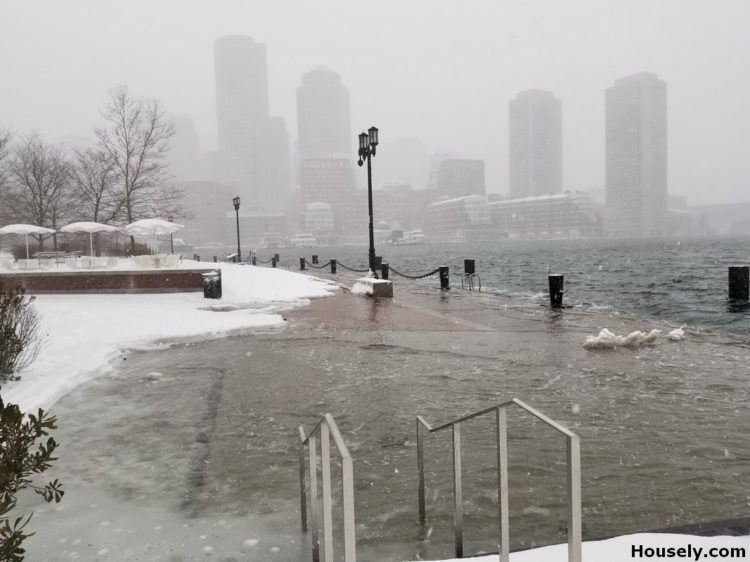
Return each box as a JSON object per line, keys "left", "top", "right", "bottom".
{"left": 417, "top": 398, "right": 581, "bottom": 562}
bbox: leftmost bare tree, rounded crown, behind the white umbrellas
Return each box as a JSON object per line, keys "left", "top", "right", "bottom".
{"left": 9, "top": 133, "right": 72, "bottom": 249}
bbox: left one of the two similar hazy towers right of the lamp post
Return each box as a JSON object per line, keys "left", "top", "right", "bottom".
{"left": 509, "top": 90, "right": 562, "bottom": 198}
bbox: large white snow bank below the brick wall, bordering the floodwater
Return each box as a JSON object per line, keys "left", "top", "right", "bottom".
{"left": 3, "top": 260, "right": 338, "bottom": 411}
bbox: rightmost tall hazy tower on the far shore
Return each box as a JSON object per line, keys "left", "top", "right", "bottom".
{"left": 606, "top": 72, "right": 667, "bottom": 236}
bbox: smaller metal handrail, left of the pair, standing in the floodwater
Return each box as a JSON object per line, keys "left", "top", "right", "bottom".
{"left": 299, "top": 414, "right": 357, "bottom": 562}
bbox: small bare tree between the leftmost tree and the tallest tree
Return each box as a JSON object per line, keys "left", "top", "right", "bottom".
{"left": 72, "top": 148, "right": 122, "bottom": 224}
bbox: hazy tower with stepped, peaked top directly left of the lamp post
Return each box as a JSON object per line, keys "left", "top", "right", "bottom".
{"left": 297, "top": 66, "right": 356, "bottom": 158}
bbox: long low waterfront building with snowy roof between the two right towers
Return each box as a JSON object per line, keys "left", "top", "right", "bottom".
{"left": 489, "top": 191, "right": 601, "bottom": 239}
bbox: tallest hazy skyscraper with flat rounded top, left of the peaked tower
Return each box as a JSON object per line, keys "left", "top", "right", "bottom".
{"left": 214, "top": 35, "right": 268, "bottom": 208}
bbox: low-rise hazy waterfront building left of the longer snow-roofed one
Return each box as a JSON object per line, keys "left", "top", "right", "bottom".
{"left": 424, "top": 195, "right": 496, "bottom": 242}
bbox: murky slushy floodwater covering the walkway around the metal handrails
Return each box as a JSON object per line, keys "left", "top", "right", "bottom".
{"left": 19, "top": 285, "right": 750, "bottom": 562}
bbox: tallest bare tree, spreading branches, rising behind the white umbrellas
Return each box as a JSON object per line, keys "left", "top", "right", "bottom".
{"left": 94, "top": 86, "right": 181, "bottom": 249}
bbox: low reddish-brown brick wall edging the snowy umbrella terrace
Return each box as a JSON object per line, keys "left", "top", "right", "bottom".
{"left": 0, "top": 269, "right": 213, "bottom": 294}
